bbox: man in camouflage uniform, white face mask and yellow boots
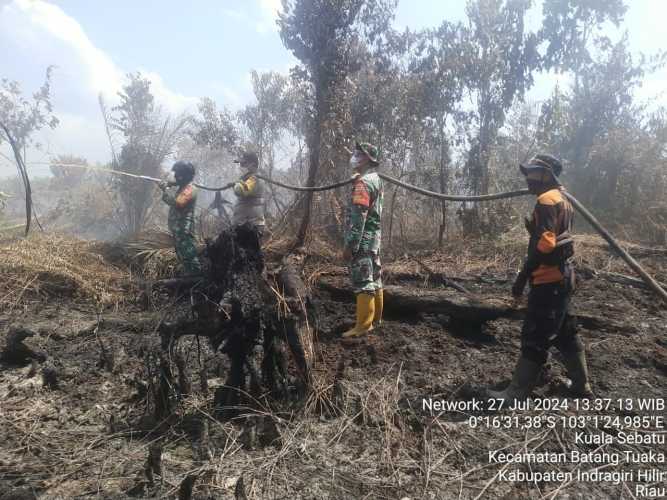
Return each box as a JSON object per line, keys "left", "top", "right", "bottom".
{"left": 343, "top": 143, "right": 384, "bottom": 339}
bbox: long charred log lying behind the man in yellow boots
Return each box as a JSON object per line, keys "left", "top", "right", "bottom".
{"left": 318, "top": 278, "right": 636, "bottom": 333}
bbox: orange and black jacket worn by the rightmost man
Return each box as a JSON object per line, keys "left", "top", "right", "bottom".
{"left": 523, "top": 188, "right": 574, "bottom": 285}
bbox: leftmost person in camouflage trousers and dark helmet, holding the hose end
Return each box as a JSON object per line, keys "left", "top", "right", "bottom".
{"left": 160, "top": 161, "right": 201, "bottom": 274}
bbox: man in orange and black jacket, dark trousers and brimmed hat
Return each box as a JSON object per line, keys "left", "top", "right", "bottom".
{"left": 489, "top": 154, "right": 593, "bottom": 400}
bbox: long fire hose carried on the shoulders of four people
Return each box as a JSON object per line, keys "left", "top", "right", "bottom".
{"left": 37, "top": 163, "right": 667, "bottom": 304}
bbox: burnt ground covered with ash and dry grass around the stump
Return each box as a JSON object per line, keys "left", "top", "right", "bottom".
{"left": 0, "top": 232, "right": 667, "bottom": 499}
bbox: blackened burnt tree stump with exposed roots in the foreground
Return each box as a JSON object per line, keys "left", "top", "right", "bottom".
{"left": 160, "top": 225, "right": 314, "bottom": 418}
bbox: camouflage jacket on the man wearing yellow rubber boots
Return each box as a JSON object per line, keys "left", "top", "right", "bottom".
{"left": 345, "top": 170, "right": 384, "bottom": 254}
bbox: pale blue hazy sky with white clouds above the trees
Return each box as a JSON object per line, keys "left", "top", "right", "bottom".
{"left": 0, "top": 0, "right": 667, "bottom": 176}
